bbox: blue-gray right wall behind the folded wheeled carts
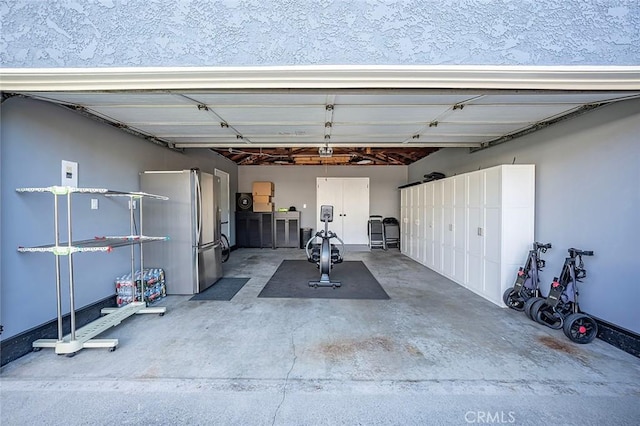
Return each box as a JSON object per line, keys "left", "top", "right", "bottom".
{"left": 409, "top": 100, "right": 640, "bottom": 333}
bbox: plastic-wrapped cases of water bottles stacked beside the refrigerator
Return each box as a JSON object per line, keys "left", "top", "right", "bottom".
{"left": 116, "top": 268, "right": 167, "bottom": 307}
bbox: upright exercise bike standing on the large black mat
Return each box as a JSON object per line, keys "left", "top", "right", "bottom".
{"left": 305, "top": 206, "right": 344, "bottom": 288}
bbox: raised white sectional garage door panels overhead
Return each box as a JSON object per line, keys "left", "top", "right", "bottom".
{"left": 19, "top": 89, "right": 640, "bottom": 148}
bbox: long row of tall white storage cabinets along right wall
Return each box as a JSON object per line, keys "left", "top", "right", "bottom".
{"left": 401, "top": 164, "right": 535, "bottom": 306}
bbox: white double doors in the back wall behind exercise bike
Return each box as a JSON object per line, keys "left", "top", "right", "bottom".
{"left": 316, "top": 178, "right": 369, "bottom": 244}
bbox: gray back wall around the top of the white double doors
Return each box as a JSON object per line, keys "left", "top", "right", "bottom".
{"left": 238, "top": 166, "right": 408, "bottom": 228}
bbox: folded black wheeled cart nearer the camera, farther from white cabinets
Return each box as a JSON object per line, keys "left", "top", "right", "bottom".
{"left": 531, "top": 248, "right": 598, "bottom": 344}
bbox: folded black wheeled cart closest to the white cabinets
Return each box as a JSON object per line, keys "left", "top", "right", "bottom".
{"left": 502, "top": 242, "right": 551, "bottom": 311}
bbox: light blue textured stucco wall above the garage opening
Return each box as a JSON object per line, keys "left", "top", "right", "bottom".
{"left": 0, "top": 0, "right": 640, "bottom": 68}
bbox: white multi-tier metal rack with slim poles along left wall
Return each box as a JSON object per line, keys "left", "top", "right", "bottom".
{"left": 16, "top": 186, "right": 169, "bottom": 356}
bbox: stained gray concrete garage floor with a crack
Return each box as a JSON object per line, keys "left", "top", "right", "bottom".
{"left": 0, "top": 249, "right": 640, "bottom": 426}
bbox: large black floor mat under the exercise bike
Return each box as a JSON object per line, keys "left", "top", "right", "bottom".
{"left": 258, "top": 260, "right": 389, "bottom": 299}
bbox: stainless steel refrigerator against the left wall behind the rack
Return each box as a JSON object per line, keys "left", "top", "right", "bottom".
{"left": 140, "top": 169, "right": 222, "bottom": 294}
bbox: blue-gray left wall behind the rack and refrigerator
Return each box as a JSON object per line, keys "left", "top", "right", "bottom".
{"left": 0, "top": 98, "right": 237, "bottom": 339}
